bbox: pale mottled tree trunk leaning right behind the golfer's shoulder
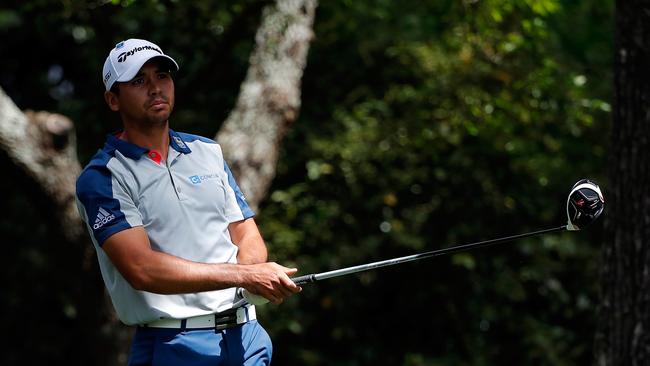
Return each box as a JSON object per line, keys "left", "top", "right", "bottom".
{"left": 216, "top": 0, "right": 317, "bottom": 209}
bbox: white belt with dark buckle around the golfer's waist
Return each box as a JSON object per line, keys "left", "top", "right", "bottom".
{"left": 140, "top": 306, "right": 257, "bottom": 330}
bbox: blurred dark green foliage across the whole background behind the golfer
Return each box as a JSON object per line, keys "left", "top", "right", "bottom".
{"left": 0, "top": 0, "right": 613, "bottom": 366}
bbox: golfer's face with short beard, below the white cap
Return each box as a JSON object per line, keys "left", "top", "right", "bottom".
{"left": 107, "top": 62, "right": 174, "bottom": 127}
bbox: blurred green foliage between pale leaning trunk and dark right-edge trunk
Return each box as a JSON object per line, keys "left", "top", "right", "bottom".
{"left": 260, "top": 1, "right": 611, "bottom": 365}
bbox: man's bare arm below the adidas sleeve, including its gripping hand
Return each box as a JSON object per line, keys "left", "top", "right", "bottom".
{"left": 102, "top": 226, "right": 300, "bottom": 303}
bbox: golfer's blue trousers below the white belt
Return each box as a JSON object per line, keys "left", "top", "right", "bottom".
{"left": 128, "top": 320, "right": 273, "bottom": 366}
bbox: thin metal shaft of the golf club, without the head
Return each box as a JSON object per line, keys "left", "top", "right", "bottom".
{"left": 292, "top": 225, "right": 567, "bottom": 285}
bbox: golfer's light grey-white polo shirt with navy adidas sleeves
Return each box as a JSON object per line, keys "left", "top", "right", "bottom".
{"left": 76, "top": 130, "right": 254, "bottom": 324}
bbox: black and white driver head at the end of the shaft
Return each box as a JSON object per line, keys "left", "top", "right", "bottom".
{"left": 566, "top": 179, "right": 605, "bottom": 231}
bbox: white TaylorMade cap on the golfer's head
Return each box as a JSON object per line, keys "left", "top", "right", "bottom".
{"left": 102, "top": 38, "right": 178, "bottom": 90}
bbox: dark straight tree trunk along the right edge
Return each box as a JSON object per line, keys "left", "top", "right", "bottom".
{"left": 595, "top": 0, "right": 650, "bottom": 366}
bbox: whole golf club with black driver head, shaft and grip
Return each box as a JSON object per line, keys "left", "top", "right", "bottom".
{"left": 242, "top": 179, "right": 605, "bottom": 305}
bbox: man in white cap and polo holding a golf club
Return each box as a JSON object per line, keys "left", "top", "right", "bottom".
{"left": 77, "top": 39, "right": 301, "bottom": 365}
